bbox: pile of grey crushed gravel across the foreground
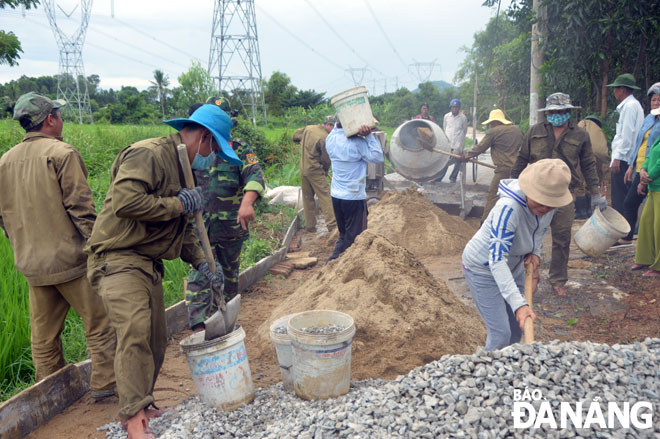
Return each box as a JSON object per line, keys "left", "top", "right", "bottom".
{"left": 100, "top": 339, "right": 660, "bottom": 439}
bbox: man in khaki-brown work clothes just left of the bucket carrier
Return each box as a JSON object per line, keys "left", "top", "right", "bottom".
{"left": 293, "top": 116, "right": 337, "bottom": 232}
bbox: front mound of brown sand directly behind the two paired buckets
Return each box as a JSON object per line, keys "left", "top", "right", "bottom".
{"left": 253, "top": 230, "right": 486, "bottom": 379}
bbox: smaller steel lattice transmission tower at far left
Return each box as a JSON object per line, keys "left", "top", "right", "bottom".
{"left": 42, "top": 0, "right": 93, "bottom": 123}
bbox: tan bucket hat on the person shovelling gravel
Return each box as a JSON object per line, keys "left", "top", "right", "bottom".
{"left": 518, "top": 159, "right": 573, "bottom": 207}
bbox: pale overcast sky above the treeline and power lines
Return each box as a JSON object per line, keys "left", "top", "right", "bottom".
{"left": 0, "top": 0, "right": 509, "bottom": 97}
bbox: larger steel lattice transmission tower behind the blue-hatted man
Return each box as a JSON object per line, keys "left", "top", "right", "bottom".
{"left": 208, "top": 0, "right": 266, "bottom": 125}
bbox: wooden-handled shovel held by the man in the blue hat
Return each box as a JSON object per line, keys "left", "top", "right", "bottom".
{"left": 176, "top": 144, "right": 241, "bottom": 340}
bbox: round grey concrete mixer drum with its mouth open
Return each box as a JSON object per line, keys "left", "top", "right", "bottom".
{"left": 389, "top": 119, "right": 451, "bottom": 182}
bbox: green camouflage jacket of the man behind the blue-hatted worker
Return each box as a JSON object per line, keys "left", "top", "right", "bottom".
{"left": 195, "top": 141, "right": 264, "bottom": 242}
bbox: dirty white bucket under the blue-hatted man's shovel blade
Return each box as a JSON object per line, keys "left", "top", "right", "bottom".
{"left": 179, "top": 325, "right": 254, "bottom": 411}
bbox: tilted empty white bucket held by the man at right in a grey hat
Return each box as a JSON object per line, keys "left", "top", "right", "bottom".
{"left": 574, "top": 207, "right": 630, "bottom": 257}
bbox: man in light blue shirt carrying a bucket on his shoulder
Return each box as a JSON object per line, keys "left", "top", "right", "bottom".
{"left": 325, "top": 119, "right": 384, "bottom": 263}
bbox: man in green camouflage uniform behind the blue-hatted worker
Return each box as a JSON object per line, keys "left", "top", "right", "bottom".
{"left": 185, "top": 97, "right": 264, "bottom": 329}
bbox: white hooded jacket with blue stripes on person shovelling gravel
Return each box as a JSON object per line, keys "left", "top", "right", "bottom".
{"left": 463, "top": 179, "right": 555, "bottom": 312}
